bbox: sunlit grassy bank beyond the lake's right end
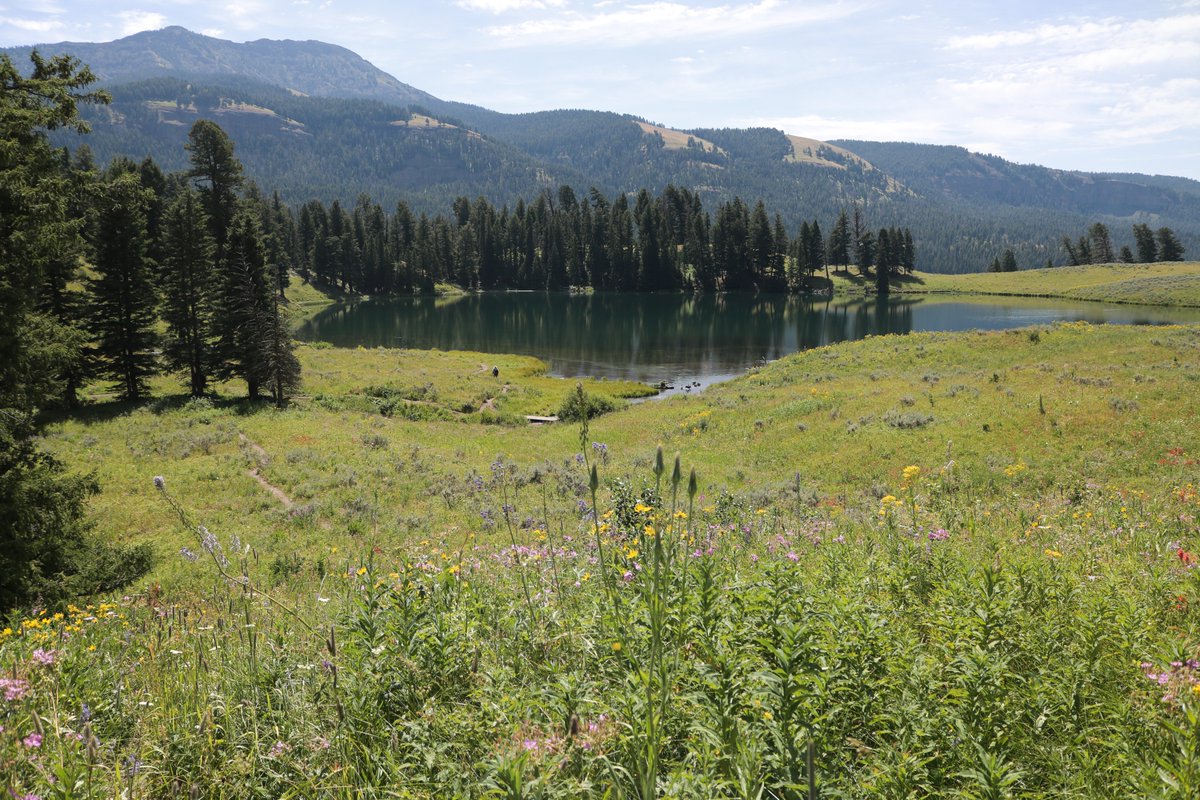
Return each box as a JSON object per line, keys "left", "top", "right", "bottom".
{"left": 833, "top": 261, "right": 1200, "bottom": 306}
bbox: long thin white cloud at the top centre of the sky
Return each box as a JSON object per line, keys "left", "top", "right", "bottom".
{"left": 487, "top": 0, "right": 857, "bottom": 47}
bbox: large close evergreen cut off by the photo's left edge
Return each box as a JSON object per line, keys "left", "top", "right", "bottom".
{"left": 0, "top": 50, "right": 149, "bottom": 612}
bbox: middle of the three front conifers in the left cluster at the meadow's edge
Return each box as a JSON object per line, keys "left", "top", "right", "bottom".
{"left": 162, "top": 190, "right": 217, "bottom": 397}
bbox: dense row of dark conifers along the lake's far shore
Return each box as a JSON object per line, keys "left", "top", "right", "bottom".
{"left": 292, "top": 186, "right": 916, "bottom": 295}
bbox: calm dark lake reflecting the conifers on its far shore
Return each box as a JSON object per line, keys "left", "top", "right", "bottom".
{"left": 298, "top": 291, "right": 1200, "bottom": 391}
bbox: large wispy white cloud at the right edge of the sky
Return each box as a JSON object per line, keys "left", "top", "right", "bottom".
{"left": 916, "top": 13, "right": 1200, "bottom": 163}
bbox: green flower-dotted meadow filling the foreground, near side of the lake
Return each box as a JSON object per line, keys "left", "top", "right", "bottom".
{"left": 0, "top": 287, "right": 1200, "bottom": 798}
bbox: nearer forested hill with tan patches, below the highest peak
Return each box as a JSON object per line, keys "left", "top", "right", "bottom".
{"left": 63, "top": 76, "right": 568, "bottom": 212}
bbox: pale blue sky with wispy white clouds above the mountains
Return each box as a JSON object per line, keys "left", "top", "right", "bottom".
{"left": 0, "top": 0, "right": 1200, "bottom": 179}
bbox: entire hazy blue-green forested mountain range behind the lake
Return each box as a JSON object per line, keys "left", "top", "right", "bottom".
{"left": 4, "top": 28, "right": 1200, "bottom": 272}
